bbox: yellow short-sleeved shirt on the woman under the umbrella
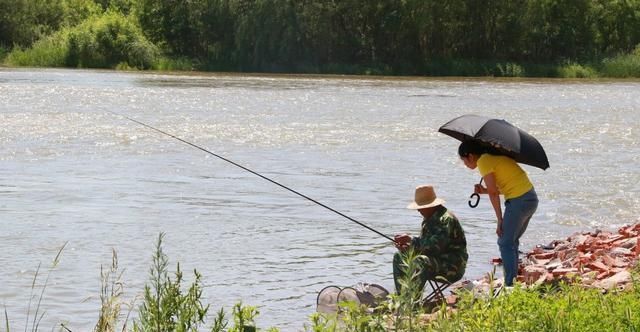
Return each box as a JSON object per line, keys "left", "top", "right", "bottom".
{"left": 478, "top": 153, "right": 533, "bottom": 199}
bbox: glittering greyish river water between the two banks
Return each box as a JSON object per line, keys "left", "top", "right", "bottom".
{"left": 0, "top": 68, "right": 640, "bottom": 331}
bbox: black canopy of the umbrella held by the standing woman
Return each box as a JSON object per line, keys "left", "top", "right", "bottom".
{"left": 438, "top": 114, "right": 549, "bottom": 170}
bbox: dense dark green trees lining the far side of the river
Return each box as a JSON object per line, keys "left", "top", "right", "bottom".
{"left": 0, "top": 0, "right": 640, "bottom": 76}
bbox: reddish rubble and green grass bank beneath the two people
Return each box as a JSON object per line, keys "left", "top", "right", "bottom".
{"left": 313, "top": 223, "right": 640, "bottom": 331}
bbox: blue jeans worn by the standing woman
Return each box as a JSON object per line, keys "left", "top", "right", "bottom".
{"left": 498, "top": 189, "right": 538, "bottom": 286}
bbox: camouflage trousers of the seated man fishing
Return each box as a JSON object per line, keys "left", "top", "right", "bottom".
{"left": 393, "top": 252, "right": 465, "bottom": 294}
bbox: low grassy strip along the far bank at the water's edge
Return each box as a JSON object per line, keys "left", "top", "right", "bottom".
{"left": 0, "top": 50, "right": 640, "bottom": 79}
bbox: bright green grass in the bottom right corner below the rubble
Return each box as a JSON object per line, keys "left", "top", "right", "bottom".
{"left": 426, "top": 282, "right": 640, "bottom": 331}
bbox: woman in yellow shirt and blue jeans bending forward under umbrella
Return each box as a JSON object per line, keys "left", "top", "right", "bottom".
{"left": 458, "top": 140, "right": 538, "bottom": 286}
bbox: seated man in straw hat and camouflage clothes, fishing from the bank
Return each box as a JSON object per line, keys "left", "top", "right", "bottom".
{"left": 393, "top": 185, "right": 468, "bottom": 294}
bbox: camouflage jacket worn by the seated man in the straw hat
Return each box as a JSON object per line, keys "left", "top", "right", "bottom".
{"left": 411, "top": 206, "right": 469, "bottom": 278}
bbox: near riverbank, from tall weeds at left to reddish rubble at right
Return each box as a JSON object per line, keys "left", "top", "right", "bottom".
{"left": 12, "top": 223, "right": 640, "bottom": 332}
